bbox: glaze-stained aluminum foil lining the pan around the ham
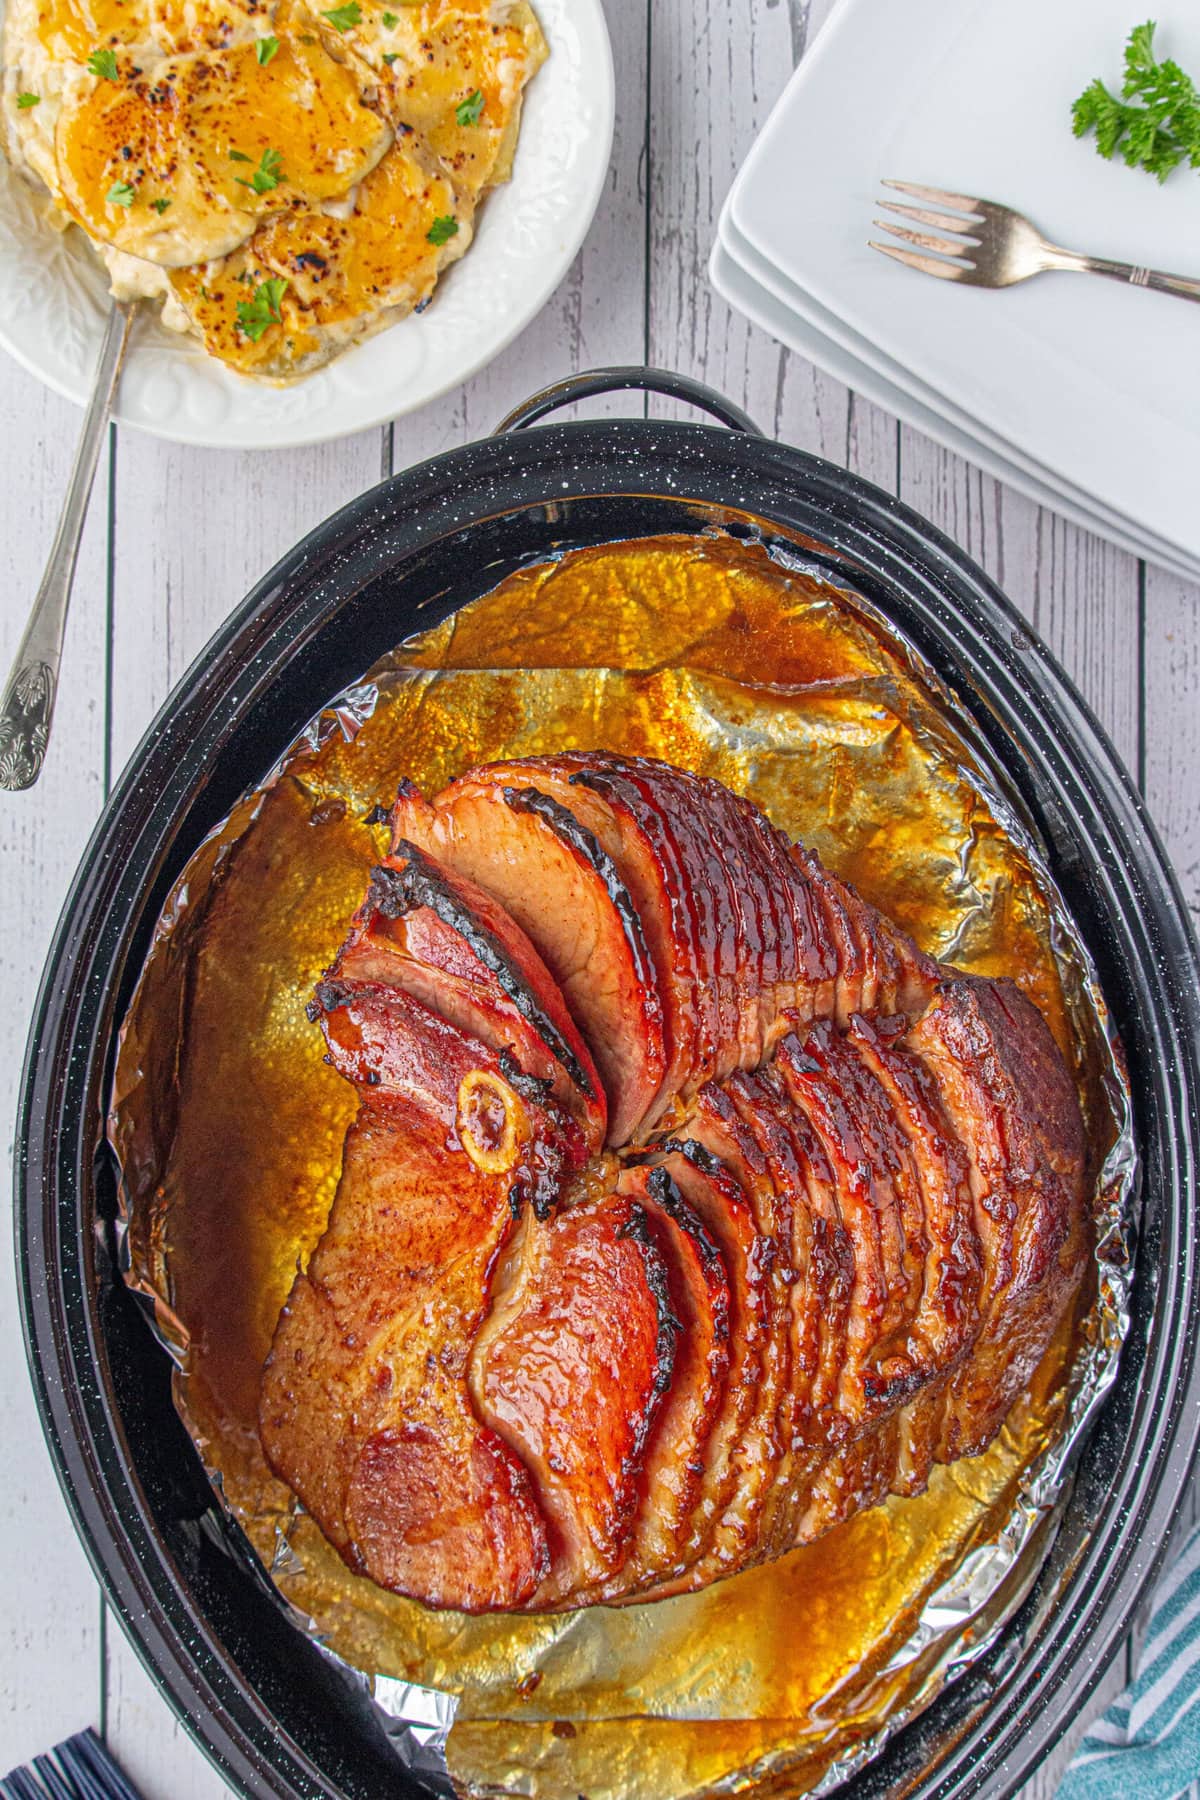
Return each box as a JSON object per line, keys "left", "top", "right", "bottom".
{"left": 110, "top": 533, "right": 1137, "bottom": 1800}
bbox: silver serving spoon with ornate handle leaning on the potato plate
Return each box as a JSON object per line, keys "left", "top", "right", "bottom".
{"left": 0, "top": 301, "right": 137, "bottom": 792}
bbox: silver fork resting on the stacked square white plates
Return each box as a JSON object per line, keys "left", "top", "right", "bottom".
{"left": 871, "top": 182, "right": 1200, "bottom": 301}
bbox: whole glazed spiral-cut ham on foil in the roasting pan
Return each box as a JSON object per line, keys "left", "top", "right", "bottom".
{"left": 259, "top": 752, "right": 1087, "bottom": 1611}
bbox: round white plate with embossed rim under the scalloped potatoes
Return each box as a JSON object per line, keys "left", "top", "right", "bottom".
{"left": 0, "top": 0, "right": 613, "bottom": 450}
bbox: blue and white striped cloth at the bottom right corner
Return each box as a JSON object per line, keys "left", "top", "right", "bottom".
{"left": 1058, "top": 1526, "right": 1200, "bottom": 1800}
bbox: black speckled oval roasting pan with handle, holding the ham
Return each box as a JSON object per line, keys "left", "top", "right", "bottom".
{"left": 16, "top": 369, "right": 1200, "bottom": 1800}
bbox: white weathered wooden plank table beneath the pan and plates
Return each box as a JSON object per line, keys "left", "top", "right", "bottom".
{"left": 0, "top": 0, "right": 1200, "bottom": 1800}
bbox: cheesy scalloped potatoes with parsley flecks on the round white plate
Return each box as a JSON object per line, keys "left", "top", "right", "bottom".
{"left": 4, "top": 0, "right": 547, "bottom": 382}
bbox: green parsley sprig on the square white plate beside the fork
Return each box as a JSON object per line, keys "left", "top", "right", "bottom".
{"left": 1070, "top": 20, "right": 1200, "bottom": 182}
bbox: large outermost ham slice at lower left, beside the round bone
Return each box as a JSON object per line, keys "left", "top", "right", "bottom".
{"left": 259, "top": 995, "right": 551, "bottom": 1611}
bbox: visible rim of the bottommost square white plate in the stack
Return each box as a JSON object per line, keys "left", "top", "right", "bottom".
{"left": 709, "top": 239, "right": 1196, "bottom": 580}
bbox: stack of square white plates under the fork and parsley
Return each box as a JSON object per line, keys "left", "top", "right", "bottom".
{"left": 711, "top": 0, "right": 1200, "bottom": 580}
